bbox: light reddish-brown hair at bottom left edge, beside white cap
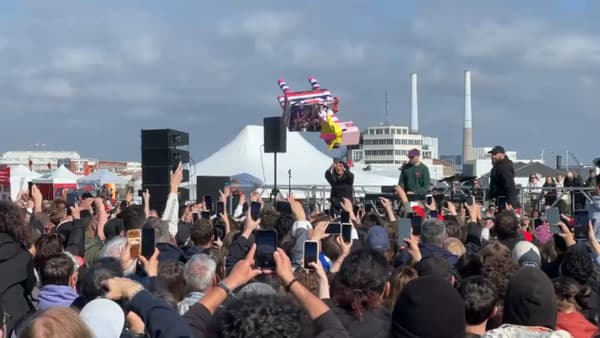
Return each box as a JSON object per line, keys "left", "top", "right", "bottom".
{"left": 19, "top": 307, "right": 93, "bottom": 338}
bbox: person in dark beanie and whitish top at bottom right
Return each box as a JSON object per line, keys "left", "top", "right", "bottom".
{"left": 483, "top": 267, "right": 571, "bottom": 338}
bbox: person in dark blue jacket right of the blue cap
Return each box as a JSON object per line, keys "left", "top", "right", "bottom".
{"left": 394, "top": 218, "right": 458, "bottom": 267}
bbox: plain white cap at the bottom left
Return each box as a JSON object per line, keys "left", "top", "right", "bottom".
{"left": 79, "top": 298, "right": 125, "bottom": 338}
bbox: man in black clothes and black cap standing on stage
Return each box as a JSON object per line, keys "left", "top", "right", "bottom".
{"left": 488, "top": 146, "right": 519, "bottom": 208}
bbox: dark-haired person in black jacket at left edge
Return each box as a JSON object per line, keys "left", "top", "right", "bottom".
{"left": 0, "top": 201, "right": 36, "bottom": 332}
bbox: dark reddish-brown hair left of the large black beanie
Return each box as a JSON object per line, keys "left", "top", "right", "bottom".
{"left": 332, "top": 249, "right": 389, "bottom": 320}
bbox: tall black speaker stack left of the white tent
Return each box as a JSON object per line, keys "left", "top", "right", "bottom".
{"left": 142, "top": 129, "right": 190, "bottom": 213}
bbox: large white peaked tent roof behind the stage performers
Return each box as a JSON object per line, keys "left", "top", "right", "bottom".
{"left": 195, "top": 126, "right": 397, "bottom": 187}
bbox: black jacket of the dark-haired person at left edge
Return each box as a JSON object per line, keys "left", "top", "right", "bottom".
{"left": 0, "top": 233, "right": 35, "bottom": 332}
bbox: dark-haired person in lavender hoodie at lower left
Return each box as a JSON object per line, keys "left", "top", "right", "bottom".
{"left": 38, "top": 253, "right": 78, "bottom": 310}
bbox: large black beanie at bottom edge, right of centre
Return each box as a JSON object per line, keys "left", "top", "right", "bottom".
{"left": 390, "top": 276, "right": 467, "bottom": 338}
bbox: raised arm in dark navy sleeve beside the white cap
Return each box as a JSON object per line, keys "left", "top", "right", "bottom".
{"left": 104, "top": 278, "right": 191, "bottom": 338}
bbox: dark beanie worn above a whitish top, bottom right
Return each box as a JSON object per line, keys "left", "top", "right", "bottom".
{"left": 503, "top": 267, "right": 558, "bottom": 330}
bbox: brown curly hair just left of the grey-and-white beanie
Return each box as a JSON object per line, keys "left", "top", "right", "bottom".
{"left": 481, "top": 241, "right": 518, "bottom": 299}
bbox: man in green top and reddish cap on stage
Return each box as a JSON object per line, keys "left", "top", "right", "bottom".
{"left": 398, "top": 149, "right": 431, "bottom": 198}
